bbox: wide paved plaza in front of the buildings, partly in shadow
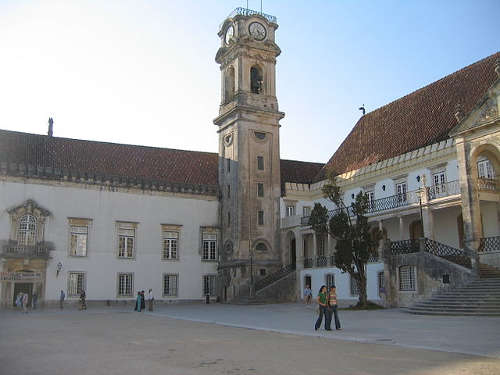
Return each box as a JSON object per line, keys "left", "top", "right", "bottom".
{"left": 0, "top": 304, "right": 500, "bottom": 375}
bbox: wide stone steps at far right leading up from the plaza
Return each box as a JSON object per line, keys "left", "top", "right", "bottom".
{"left": 407, "top": 264, "right": 500, "bottom": 316}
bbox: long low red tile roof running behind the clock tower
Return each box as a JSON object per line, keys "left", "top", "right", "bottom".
{"left": 0, "top": 130, "right": 323, "bottom": 194}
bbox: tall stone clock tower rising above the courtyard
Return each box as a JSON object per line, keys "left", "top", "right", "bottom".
{"left": 214, "top": 8, "right": 285, "bottom": 301}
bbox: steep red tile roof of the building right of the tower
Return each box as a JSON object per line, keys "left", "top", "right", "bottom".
{"left": 316, "top": 52, "right": 500, "bottom": 180}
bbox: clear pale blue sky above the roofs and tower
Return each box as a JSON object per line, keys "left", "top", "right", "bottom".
{"left": 0, "top": 0, "right": 500, "bottom": 162}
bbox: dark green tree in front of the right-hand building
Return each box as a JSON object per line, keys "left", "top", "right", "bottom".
{"left": 309, "top": 176, "right": 381, "bottom": 307}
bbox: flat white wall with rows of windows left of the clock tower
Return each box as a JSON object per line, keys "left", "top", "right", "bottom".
{"left": 0, "top": 182, "right": 218, "bottom": 300}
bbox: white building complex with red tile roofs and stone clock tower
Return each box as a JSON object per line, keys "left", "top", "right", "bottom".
{"left": 0, "top": 8, "right": 500, "bottom": 306}
